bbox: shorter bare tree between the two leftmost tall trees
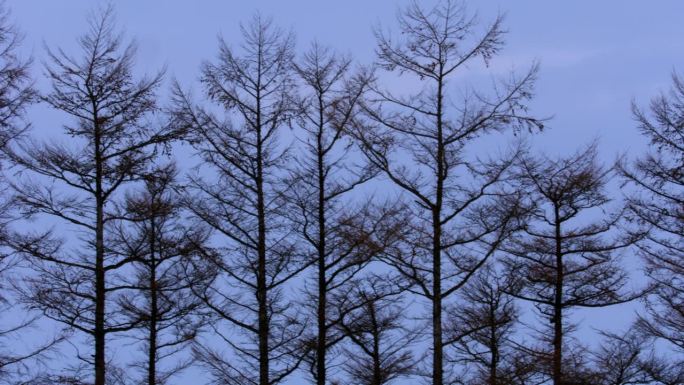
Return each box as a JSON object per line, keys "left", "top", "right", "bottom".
{"left": 111, "top": 163, "right": 211, "bottom": 385}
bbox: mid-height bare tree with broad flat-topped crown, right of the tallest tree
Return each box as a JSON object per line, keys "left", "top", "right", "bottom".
{"left": 503, "top": 145, "right": 640, "bottom": 385}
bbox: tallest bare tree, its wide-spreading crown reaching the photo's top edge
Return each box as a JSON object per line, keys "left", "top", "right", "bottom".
{"left": 358, "top": 1, "right": 541, "bottom": 385}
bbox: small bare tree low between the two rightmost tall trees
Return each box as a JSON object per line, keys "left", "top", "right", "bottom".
{"left": 338, "top": 276, "right": 419, "bottom": 385}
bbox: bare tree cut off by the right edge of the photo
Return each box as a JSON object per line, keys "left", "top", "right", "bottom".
{"left": 619, "top": 75, "right": 684, "bottom": 367}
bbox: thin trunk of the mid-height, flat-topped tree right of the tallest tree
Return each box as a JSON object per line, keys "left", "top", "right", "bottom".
{"left": 553, "top": 205, "right": 564, "bottom": 385}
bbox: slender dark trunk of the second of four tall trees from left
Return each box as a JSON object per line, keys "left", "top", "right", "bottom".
{"left": 255, "top": 56, "right": 271, "bottom": 385}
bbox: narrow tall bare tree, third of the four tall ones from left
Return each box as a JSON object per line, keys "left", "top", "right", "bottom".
{"left": 285, "top": 43, "right": 396, "bottom": 385}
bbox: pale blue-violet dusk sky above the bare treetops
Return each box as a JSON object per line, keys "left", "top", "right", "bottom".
{"left": 6, "top": 0, "right": 684, "bottom": 384}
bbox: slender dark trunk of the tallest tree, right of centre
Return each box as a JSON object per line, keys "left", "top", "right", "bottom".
{"left": 432, "top": 70, "right": 444, "bottom": 385}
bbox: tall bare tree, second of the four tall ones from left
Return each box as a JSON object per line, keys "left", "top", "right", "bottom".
{"left": 171, "top": 15, "right": 306, "bottom": 385}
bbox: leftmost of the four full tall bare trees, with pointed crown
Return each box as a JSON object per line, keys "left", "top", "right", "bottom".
{"left": 6, "top": 8, "right": 179, "bottom": 385}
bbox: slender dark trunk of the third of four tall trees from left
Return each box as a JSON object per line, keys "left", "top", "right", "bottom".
{"left": 316, "top": 93, "right": 327, "bottom": 385}
